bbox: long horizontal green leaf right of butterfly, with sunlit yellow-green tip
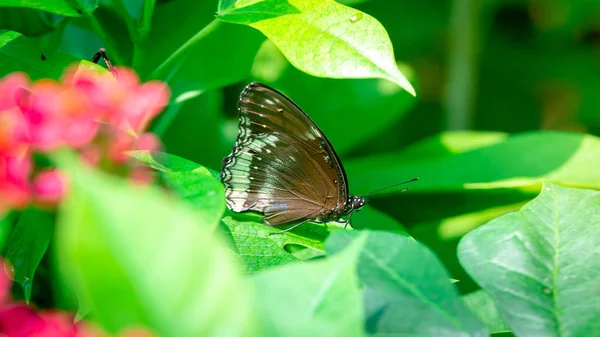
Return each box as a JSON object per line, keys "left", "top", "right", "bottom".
{"left": 345, "top": 131, "right": 600, "bottom": 193}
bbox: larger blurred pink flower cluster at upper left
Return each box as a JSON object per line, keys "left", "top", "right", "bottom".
{"left": 0, "top": 68, "right": 170, "bottom": 215}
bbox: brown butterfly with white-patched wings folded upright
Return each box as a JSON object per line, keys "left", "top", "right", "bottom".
{"left": 221, "top": 82, "right": 418, "bottom": 233}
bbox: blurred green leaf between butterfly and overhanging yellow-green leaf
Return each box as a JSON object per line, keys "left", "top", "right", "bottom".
{"left": 252, "top": 41, "right": 416, "bottom": 154}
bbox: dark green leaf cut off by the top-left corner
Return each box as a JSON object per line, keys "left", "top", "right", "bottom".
{"left": 0, "top": 0, "right": 99, "bottom": 16}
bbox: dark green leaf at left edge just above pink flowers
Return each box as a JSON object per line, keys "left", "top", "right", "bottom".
{"left": 0, "top": 31, "right": 105, "bottom": 79}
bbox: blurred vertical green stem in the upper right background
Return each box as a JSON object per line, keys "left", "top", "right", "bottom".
{"left": 444, "top": 0, "right": 481, "bottom": 130}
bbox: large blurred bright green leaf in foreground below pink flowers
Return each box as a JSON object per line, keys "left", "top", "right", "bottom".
{"left": 57, "top": 158, "right": 255, "bottom": 337}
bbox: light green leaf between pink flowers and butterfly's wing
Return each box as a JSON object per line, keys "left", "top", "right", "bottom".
{"left": 128, "top": 151, "right": 225, "bottom": 228}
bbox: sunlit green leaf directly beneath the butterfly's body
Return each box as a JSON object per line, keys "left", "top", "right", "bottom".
{"left": 222, "top": 212, "right": 328, "bottom": 272}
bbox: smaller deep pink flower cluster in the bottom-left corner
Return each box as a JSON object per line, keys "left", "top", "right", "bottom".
{"left": 0, "top": 260, "right": 153, "bottom": 337}
